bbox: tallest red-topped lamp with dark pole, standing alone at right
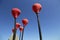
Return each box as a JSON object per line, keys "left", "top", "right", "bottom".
{"left": 32, "top": 3, "right": 42, "bottom": 40}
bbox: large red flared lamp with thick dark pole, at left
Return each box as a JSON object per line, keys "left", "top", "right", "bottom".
{"left": 12, "top": 8, "right": 21, "bottom": 40}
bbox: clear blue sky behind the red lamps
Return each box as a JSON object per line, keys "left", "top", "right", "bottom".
{"left": 0, "top": 0, "right": 60, "bottom": 40}
